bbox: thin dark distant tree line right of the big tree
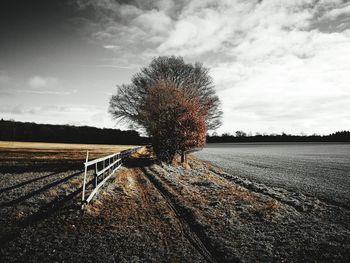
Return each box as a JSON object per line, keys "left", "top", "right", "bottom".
{"left": 207, "top": 131, "right": 350, "bottom": 143}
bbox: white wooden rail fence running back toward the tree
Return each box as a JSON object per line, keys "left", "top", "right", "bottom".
{"left": 82, "top": 147, "right": 142, "bottom": 207}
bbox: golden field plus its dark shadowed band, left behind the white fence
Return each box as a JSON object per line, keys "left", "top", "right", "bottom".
{"left": 0, "top": 141, "right": 136, "bottom": 173}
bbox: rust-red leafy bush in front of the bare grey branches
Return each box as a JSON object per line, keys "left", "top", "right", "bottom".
{"left": 142, "top": 81, "right": 208, "bottom": 162}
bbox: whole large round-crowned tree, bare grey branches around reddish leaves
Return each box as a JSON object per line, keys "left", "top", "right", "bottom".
{"left": 109, "top": 57, "right": 222, "bottom": 162}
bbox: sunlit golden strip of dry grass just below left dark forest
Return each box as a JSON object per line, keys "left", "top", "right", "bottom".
{"left": 0, "top": 141, "right": 136, "bottom": 160}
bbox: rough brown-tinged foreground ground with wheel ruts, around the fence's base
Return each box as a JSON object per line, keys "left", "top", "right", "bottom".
{"left": 0, "top": 148, "right": 350, "bottom": 262}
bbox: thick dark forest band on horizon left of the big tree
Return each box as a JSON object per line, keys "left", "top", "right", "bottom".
{"left": 0, "top": 119, "right": 148, "bottom": 144}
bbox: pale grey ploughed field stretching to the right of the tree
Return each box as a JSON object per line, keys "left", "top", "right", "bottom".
{"left": 195, "top": 143, "right": 350, "bottom": 209}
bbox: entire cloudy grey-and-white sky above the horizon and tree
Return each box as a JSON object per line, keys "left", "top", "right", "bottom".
{"left": 0, "top": 0, "right": 350, "bottom": 134}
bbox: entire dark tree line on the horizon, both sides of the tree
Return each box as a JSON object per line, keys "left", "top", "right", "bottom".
{"left": 0, "top": 119, "right": 350, "bottom": 145}
